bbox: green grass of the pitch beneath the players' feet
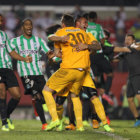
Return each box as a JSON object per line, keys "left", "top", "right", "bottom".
{"left": 0, "top": 120, "right": 140, "bottom": 140}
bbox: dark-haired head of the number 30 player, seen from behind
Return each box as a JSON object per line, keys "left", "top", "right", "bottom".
{"left": 61, "top": 14, "right": 74, "bottom": 27}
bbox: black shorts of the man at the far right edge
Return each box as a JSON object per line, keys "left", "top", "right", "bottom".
{"left": 127, "top": 75, "right": 140, "bottom": 97}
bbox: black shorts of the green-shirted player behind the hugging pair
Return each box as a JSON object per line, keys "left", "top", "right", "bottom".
{"left": 90, "top": 53, "right": 112, "bottom": 76}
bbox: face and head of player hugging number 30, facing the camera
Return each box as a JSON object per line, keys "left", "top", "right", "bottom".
{"left": 75, "top": 15, "right": 88, "bottom": 30}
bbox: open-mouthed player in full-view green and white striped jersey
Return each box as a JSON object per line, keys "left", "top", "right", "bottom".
{"left": 8, "top": 19, "right": 53, "bottom": 130}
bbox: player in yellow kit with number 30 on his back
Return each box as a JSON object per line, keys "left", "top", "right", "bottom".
{"left": 43, "top": 15, "right": 95, "bottom": 131}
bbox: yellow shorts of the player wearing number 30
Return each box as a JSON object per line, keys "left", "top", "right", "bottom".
{"left": 46, "top": 68, "right": 86, "bottom": 95}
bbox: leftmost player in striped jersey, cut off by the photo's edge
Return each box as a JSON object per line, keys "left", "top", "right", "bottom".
{"left": 0, "top": 14, "right": 32, "bottom": 131}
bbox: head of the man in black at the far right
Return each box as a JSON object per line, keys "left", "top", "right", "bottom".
{"left": 125, "top": 34, "right": 135, "bottom": 46}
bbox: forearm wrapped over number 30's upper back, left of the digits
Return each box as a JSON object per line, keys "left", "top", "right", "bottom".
{"left": 48, "top": 34, "right": 69, "bottom": 43}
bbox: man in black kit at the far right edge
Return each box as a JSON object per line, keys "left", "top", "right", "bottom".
{"left": 115, "top": 34, "right": 140, "bottom": 127}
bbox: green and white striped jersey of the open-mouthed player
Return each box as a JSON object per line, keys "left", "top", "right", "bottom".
{"left": 7, "top": 35, "right": 50, "bottom": 76}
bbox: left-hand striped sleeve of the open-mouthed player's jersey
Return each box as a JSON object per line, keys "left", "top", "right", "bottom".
{"left": 6, "top": 39, "right": 16, "bottom": 53}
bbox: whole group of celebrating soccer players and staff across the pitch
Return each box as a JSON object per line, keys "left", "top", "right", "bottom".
{"left": 0, "top": 9, "right": 140, "bottom": 132}
